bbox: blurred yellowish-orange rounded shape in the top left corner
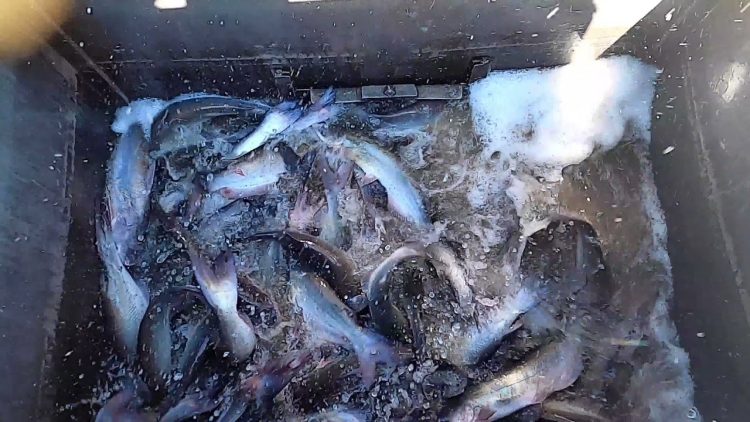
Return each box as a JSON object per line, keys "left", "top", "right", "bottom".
{"left": 0, "top": 0, "right": 73, "bottom": 59}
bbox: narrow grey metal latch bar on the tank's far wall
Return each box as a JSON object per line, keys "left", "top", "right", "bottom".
{"left": 310, "top": 84, "right": 463, "bottom": 103}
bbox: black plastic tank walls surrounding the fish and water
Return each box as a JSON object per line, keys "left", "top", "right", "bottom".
{"left": 0, "top": 0, "right": 750, "bottom": 421}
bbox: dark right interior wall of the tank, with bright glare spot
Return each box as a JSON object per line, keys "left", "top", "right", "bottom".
{"left": 618, "top": 0, "right": 750, "bottom": 421}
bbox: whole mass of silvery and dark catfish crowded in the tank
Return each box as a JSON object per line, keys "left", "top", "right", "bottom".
{"left": 96, "top": 89, "right": 607, "bottom": 421}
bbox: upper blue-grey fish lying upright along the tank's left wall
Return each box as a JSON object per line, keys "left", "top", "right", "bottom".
{"left": 105, "top": 124, "right": 156, "bottom": 265}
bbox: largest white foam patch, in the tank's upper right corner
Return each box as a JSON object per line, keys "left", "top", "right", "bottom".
{"left": 470, "top": 57, "right": 656, "bottom": 180}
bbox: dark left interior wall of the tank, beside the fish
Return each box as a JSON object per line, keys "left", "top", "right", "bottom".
{"left": 0, "top": 49, "right": 76, "bottom": 421}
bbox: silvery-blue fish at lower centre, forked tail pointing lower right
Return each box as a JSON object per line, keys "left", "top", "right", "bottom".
{"left": 289, "top": 271, "right": 396, "bottom": 385}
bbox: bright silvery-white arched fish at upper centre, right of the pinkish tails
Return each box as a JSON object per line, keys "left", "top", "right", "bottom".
{"left": 341, "top": 138, "right": 431, "bottom": 228}
